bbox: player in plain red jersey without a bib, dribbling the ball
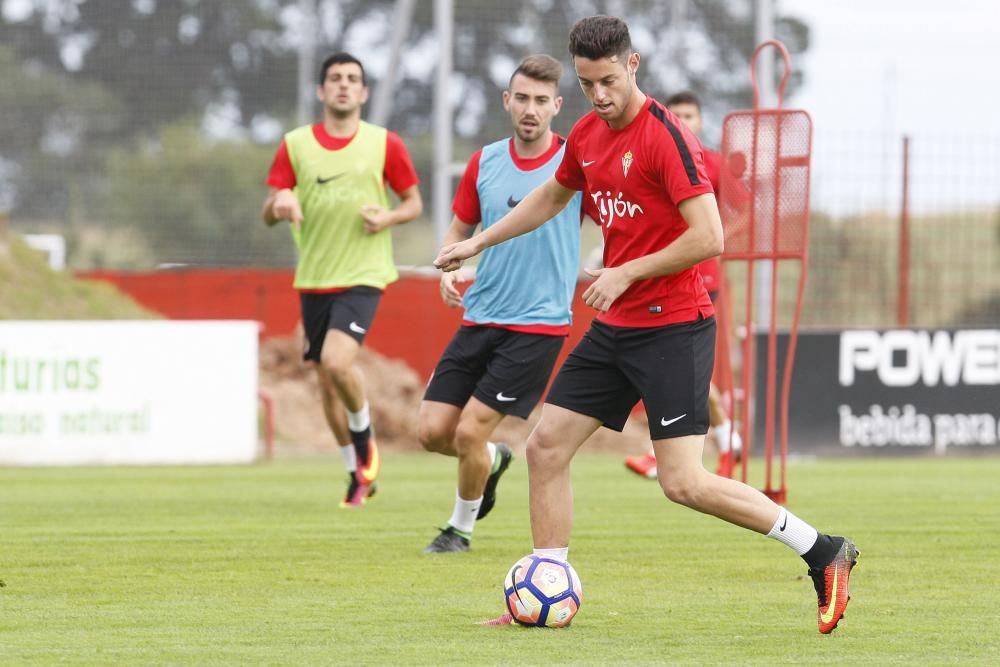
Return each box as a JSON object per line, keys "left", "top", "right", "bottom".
{"left": 434, "top": 16, "right": 858, "bottom": 633}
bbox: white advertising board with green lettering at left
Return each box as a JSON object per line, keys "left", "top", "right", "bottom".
{"left": 0, "top": 321, "right": 258, "bottom": 465}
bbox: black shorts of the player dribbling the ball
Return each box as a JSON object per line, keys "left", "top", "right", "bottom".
{"left": 545, "top": 318, "right": 715, "bottom": 440}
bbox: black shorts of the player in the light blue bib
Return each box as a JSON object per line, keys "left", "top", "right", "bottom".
{"left": 424, "top": 326, "right": 564, "bottom": 419}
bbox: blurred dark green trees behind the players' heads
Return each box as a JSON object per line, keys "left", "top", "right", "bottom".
{"left": 0, "top": 0, "right": 808, "bottom": 266}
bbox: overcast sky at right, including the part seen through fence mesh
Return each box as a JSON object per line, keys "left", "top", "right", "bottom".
{"left": 776, "top": 0, "right": 1000, "bottom": 214}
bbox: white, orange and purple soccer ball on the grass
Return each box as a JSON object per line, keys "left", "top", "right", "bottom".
{"left": 503, "top": 554, "right": 583, "bottom": 628}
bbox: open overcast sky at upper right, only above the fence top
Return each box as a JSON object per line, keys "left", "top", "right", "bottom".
{"left": 777, "top": 0, "right": 1000, "bottom": 132}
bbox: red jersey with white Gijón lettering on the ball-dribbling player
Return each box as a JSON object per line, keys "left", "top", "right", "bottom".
{"left": 556, "top": 97, "right": 714, "bottom": 327}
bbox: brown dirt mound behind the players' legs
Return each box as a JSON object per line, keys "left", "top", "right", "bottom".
{"left": 260, "top": 334, "right": 649, "bottom": 454}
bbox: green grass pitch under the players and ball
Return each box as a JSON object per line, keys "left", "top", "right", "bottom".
{"left": 0, "top": 452, "right": 1000, "bottom": 665}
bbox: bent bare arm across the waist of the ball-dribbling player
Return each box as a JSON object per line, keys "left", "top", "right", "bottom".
{"left": 582, "top": 193, "right": 723, "bottom": 312}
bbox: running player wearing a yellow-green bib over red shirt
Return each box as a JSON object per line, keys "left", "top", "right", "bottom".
{"left": 262, "top": 53, "right": 423, "bottom": 507}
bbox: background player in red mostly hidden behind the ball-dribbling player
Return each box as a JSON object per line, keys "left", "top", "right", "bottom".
{"left": 625, "top": 91, "right": 743, "bottom": 479}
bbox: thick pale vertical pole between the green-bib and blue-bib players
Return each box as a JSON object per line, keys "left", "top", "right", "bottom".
{"left": 433, "top": 0, "right": 454, "bottom": 249}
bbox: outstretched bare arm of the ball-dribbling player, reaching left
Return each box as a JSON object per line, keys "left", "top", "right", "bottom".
{"left": 434, "top": 176, "right": 576, "bottom": 271}
